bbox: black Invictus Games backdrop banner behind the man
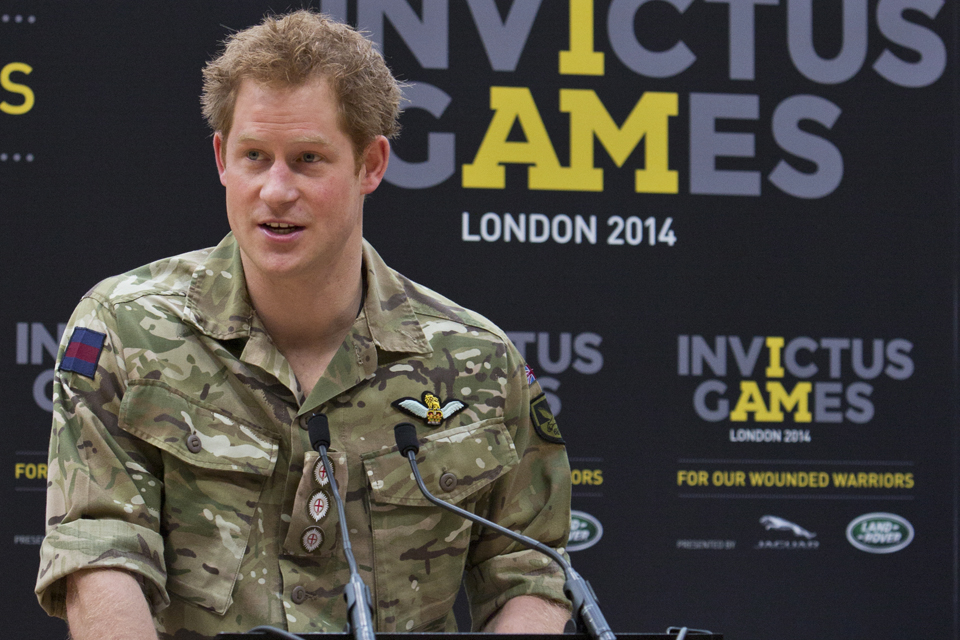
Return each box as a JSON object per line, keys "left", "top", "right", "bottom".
{"left": 0, "top": 0, "right": 960, "bottom": 640}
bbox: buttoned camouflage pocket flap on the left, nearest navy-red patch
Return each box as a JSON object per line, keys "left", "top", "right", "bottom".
{"left": 120, "top": 380, "right": 279, "bottom": 476}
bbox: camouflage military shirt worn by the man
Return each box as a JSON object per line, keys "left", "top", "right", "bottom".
{"left": 36, "top": 235, "right": 570, "bottom": 640}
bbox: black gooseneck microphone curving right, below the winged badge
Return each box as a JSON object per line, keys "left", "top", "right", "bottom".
{"left": 393, "top": 422, "right": 616, "bottom": 640}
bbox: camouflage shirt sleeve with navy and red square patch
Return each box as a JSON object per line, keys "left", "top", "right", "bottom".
{"left": 36, "top": 297, "right": 169, "bottom": 617}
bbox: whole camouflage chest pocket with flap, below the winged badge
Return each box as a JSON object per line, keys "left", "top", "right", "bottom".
{"left": 362, "top": 418, "right": 519, "bottom": 632}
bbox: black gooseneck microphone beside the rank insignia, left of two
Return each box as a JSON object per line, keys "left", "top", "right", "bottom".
{"left": 307, "top": 413, "right": 374, "bottom": 640}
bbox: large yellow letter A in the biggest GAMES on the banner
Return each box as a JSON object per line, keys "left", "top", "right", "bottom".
{"left": 463, "top": 87, "right": 560, "bottom": 189}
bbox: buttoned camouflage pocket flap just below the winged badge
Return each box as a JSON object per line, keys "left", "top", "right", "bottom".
{"left": 363, "top": 418, "right": 519, "bottom": 507}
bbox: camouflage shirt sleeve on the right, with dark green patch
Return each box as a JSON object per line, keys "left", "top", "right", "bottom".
{"left": 465, "top": 344, "right": 571, "bottom": 631}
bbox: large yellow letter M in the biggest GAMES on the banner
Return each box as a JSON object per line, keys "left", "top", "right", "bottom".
{"left": 540, "top": 89, "right": 679, "bottom": 193}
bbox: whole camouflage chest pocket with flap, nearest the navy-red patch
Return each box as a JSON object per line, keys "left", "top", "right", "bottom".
{"left": 120, "top": 380, "right": 278, "bottom": 614}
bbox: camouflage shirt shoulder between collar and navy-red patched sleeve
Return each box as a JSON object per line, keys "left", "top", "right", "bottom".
{"left": 84, "top": 249, "right": 211, "bottom": 306}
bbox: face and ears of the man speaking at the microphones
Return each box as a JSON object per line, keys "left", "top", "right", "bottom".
{"left": 213, "top": 79, "right": 389, "bottom": 283}
